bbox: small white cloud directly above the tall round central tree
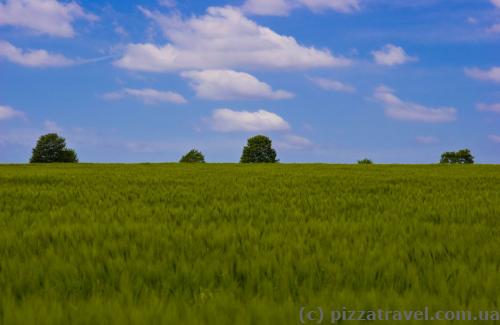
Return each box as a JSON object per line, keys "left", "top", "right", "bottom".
{"left": 211, "top": 108, "right": 290, "bottom": 132}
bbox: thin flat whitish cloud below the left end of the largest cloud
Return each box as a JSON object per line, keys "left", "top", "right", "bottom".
{"left": 103, "top": 88, "right": 187, "bottom": 104}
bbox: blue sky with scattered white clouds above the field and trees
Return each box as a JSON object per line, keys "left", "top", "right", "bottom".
{"left": 0, "top": 0, "right": 500, "bottom": 163}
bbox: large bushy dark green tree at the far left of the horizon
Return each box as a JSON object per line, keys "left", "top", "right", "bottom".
{"left": 30, "top": 133, "right": 78, "bottom": 163}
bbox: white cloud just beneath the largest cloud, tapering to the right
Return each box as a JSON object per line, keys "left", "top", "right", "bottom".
{"left": 181, "top": 70, "right": 294, "bottom": 100}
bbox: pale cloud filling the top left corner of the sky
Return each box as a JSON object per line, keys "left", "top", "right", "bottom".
{"left": 0, "top": 0, "right": 98, "bottom": 37}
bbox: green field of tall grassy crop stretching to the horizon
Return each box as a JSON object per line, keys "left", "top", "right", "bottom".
{"left": 0, "top": 164, "right": 500, "bottom": 324}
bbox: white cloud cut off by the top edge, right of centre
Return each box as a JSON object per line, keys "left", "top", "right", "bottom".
{"left": 242, "top": 0, "right": 360, "bottom": 16}
